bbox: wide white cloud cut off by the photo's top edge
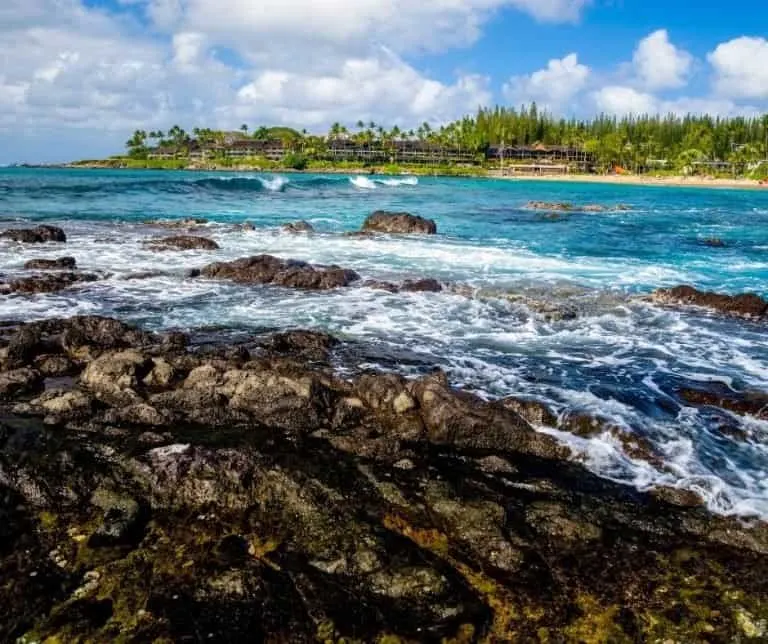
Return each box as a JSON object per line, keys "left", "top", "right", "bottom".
{"left": 138, "top": 0, "right": 591, "bottom": 58}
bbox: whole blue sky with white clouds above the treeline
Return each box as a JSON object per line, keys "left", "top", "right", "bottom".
{"left": 0, "top": 0, "right": 768, "bottom": 164}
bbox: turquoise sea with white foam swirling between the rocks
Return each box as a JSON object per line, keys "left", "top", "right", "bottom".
{"left": 0, "top": 169, "right": 768, "bottom": 516}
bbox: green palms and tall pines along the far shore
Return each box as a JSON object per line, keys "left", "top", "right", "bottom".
{"left": 118, "top": 104, "right": 768, "bottom": 179}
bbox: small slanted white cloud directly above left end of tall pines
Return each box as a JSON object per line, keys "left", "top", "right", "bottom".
{"left": 502, "top": 54, "right": 590, "bottom": 110}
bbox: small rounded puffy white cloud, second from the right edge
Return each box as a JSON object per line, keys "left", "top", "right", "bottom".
{"left": 632, "top": 29, "right": 693, "bottom": 90}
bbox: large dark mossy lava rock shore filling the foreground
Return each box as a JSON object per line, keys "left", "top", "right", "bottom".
{"left": 0, "top": 318, "right": 768, "bottom": 643}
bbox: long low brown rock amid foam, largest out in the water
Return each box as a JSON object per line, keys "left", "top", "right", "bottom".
{"left": 201, "top": 255, "right": 360, "bottom": 290}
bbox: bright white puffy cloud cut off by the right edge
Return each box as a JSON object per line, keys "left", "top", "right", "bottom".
{"left": 707, "top": 36, "right": 768, "bottom": 98}
